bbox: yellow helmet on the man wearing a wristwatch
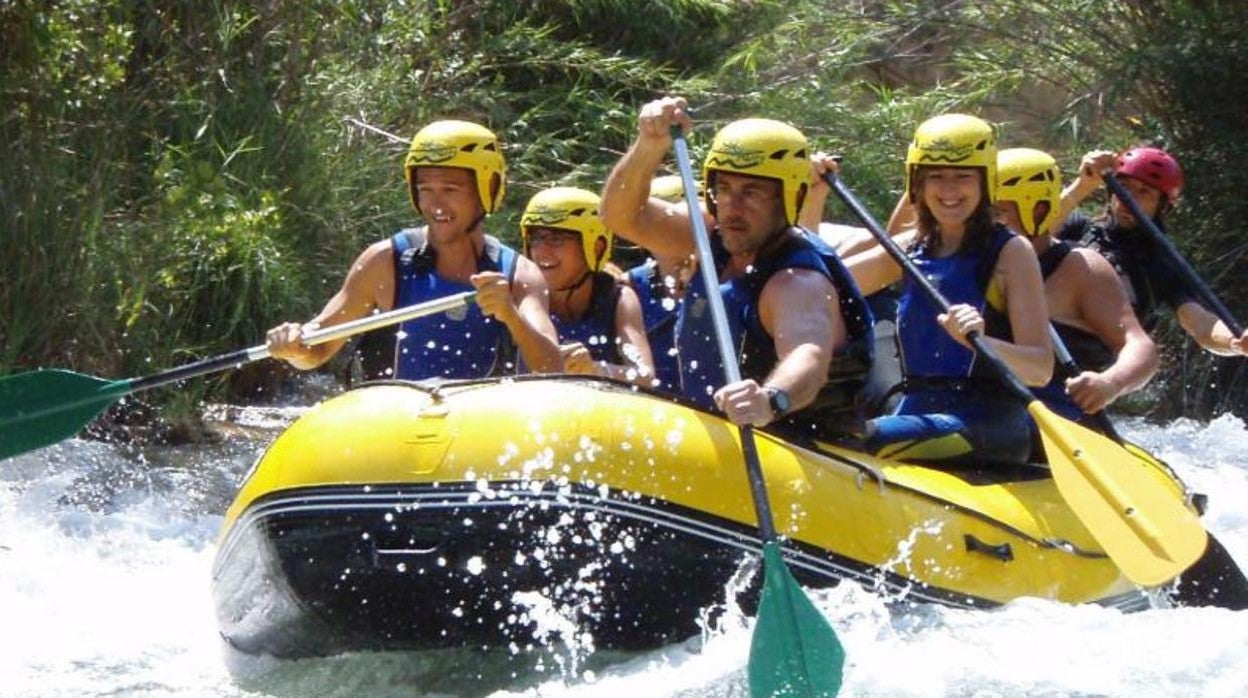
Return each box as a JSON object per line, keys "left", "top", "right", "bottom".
{"left": 703, "top": 119, "right": 810, "bottom": 225}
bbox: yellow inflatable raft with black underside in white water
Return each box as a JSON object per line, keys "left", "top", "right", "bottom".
{"left": 213, "top": 377, "right": 1184, "bottom": 657}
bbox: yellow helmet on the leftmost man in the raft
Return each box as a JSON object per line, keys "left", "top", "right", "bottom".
{"left": 403, "top": 121, "right": 507, "bottom": 214}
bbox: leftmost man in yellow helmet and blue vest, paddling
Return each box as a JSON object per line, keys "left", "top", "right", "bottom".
{"left": 267, "top": 121, "right": 563, "bottom": 380}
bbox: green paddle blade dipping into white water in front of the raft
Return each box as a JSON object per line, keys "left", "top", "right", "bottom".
{"left": 748, "top": 541, "right": 845, "bottom": 698}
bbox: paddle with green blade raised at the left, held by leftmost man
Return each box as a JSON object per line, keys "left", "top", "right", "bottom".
{"left": 0, "top": 291, "right": 475, "bottom": 460}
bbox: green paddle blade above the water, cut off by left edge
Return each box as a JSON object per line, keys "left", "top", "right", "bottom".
{"left": 0, "top": 370, "right": 130, "bottom": 460}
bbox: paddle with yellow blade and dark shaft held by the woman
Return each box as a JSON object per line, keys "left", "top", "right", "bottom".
{"left": 824, "top": 172, "right": 1208, "bottom": 587}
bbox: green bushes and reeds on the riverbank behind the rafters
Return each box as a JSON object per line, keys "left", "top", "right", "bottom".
{"left": 0, "top": 0, "right": 1248, "bottom": 416}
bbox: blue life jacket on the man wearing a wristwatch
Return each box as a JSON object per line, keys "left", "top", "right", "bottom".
{"left": 676, "top": 227, "right": 874, "bottom": 424}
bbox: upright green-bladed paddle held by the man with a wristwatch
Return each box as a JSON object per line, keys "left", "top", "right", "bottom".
{"left": 671, "top": 126, "right": 845, "bottom": 697}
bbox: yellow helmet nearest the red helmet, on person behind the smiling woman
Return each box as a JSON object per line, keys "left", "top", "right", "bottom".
{"left": 997, "top": 147, "right": 1062, "bottom": 237}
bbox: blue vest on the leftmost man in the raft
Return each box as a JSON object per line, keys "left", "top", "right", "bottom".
{"left": 391, "top": 229, "right": 518, "bottom": 381}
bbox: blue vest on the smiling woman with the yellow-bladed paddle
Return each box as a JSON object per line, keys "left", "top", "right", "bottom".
{"left": 897, "top": 226, "right": 1015, "bottom": 380}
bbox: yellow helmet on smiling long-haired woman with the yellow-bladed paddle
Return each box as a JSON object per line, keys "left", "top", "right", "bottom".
{"left": 906, "top": 114, "right": 997, "bottom": 204}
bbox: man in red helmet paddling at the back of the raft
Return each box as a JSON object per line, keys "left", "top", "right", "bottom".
{"left": 1058, "top": 147, "right": 1248, "bottom": 356}
